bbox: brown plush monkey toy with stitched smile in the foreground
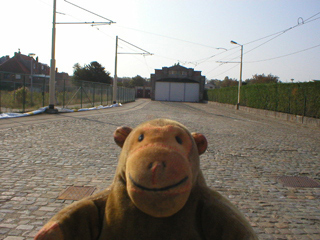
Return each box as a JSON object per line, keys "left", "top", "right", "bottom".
{"left": 35, "top": 119, "right": 257, "bottom": 240}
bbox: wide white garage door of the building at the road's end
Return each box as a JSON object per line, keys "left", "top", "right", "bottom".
{"left": 155, "top": 82, "right": 199, "bottom": 102}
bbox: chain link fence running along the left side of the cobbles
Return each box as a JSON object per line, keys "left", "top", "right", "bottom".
{"left": 0, "top": 72, "right": 135, "bottom": 113}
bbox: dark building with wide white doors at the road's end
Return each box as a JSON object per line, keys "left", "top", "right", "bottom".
{"left": 151, "top": 64, "right": 205, "bottom": 102}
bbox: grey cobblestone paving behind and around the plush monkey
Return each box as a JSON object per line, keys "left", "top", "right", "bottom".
{"left": 0, "top": 100, "right": 320, "bottom": 240}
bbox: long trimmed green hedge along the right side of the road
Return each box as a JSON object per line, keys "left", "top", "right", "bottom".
{"left": 206, "top": 82, "right": 320, "bottom": 118}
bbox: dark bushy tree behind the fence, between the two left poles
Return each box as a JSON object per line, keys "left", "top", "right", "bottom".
{"left": 72, "top": 61, "right": 112, "bottom": 84}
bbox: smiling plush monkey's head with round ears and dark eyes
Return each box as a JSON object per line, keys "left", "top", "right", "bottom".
{"left": 114, "top": 119, "right": 207, "bottom": 217}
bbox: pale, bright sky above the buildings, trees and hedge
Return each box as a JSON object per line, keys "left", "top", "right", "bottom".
{"left": 0, "top": 0, "right": 320, "bottom": 82}
